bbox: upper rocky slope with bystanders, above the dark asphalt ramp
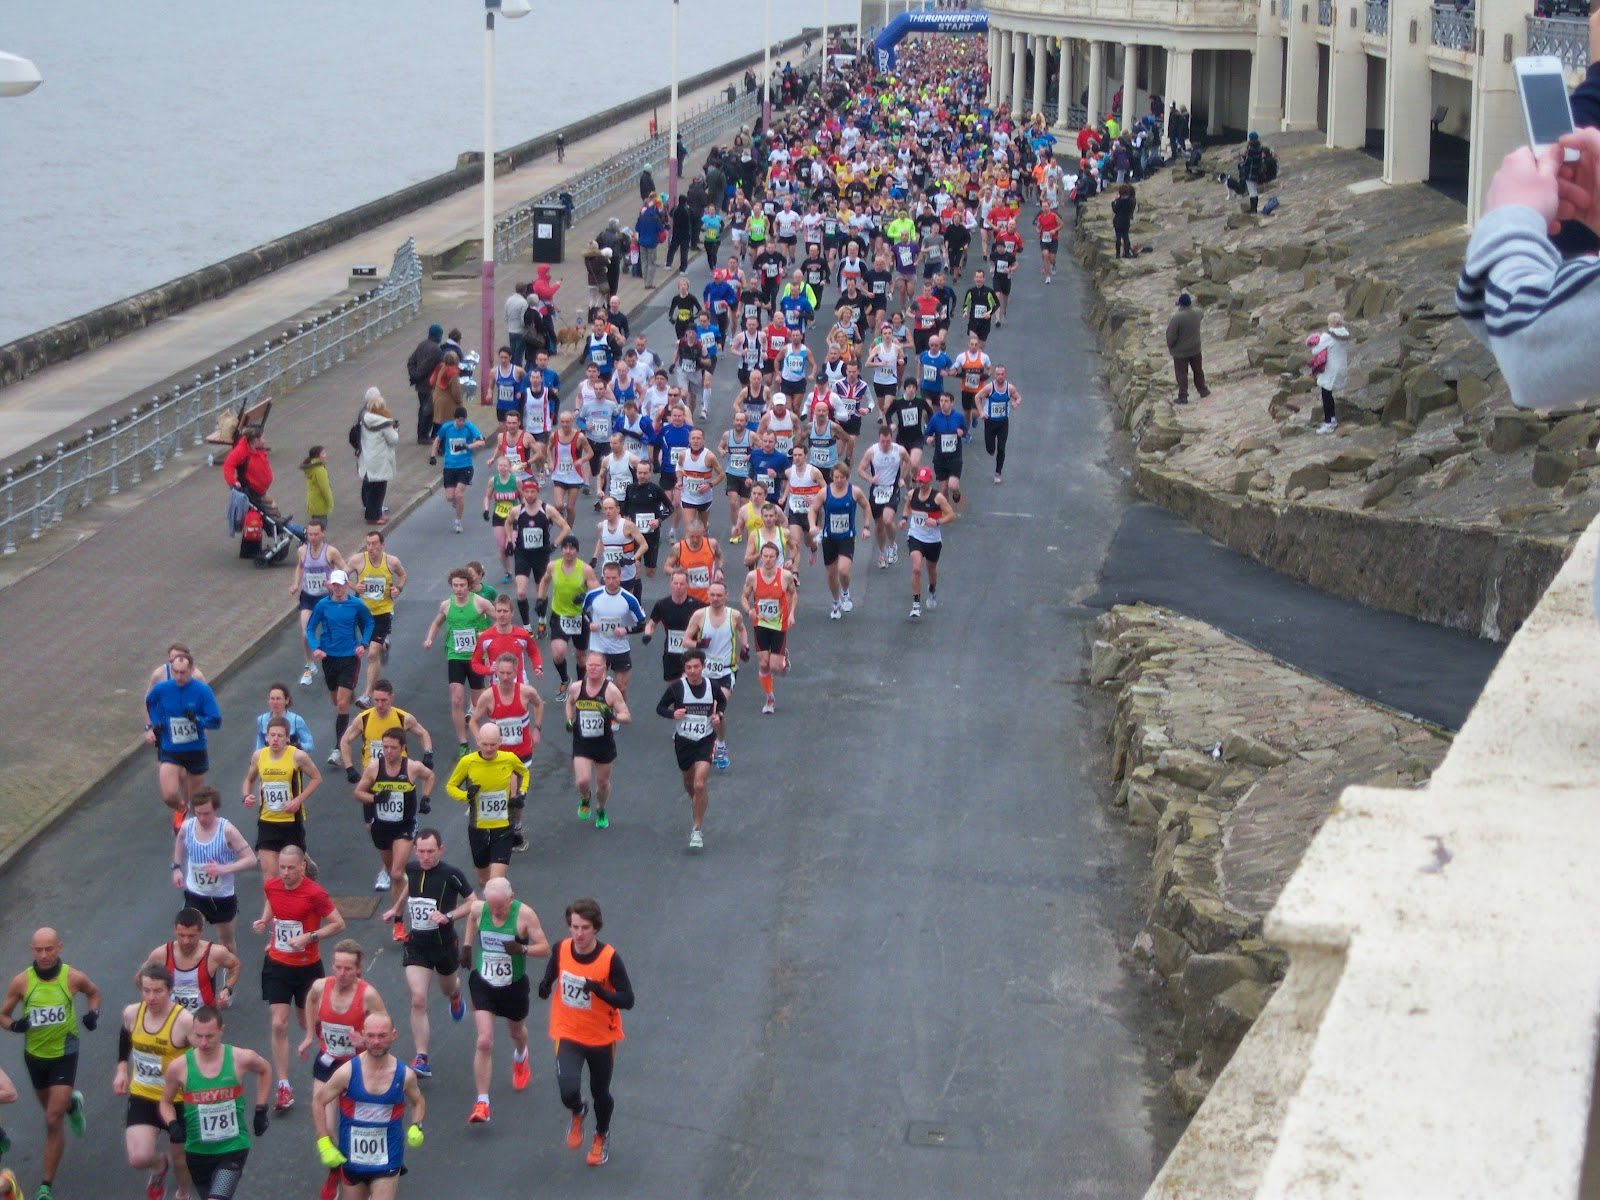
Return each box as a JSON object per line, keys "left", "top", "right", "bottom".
{"left": 1077, "top": 136, "right": 1580, "bottom": 640}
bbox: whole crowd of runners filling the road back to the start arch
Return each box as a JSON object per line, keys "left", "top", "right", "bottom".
{"left": 0, "top": 30, "right": 1066, "bottom": 1200}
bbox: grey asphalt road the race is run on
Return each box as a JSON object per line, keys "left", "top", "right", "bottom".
{"left": 0, "top": 249, "right": 1170, "bottom": 1200}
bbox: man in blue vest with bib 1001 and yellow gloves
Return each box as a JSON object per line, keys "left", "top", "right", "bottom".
{"left": 312, "top": 1013, "right": 427, "bottom": 1200}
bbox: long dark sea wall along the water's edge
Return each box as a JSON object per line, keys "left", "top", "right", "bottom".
{"left": 0, "top": 34, "right": 806, "bottom": 387}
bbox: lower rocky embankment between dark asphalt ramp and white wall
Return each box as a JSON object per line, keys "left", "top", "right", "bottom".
{"left": 1091, "top": 605, "right": 1450, "bottom": 1114}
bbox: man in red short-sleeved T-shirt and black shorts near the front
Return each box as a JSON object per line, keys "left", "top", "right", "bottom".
{"left": 249, "top": 845, "right": 344, "bottom": 1120}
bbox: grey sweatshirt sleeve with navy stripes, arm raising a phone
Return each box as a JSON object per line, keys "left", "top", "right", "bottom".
{"left": 1456, "top": 205, "right": 1600, "bottom": 408}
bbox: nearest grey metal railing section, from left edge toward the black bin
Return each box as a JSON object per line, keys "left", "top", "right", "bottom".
{"left": 0, "top": 238, "right": 422, "bottom": 555}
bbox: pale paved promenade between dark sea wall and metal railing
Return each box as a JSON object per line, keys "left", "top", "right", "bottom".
{"left": 0, "top": 58, "right": 764, "bottom": 461}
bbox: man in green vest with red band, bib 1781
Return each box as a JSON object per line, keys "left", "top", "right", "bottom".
{"left": 162, "top": 1005, "right": 272, "bottom": 1200}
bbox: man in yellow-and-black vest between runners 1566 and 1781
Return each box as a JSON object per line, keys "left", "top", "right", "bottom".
{"left": 112, "top": 963, "right": 190, "bottom": 1200}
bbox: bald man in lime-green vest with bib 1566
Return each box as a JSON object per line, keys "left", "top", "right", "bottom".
{"left": 0, "top": 928, "right": 99, "bottom": 1200}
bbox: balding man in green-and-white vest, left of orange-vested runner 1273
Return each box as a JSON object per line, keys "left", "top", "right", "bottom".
{"left": 461, "top": 878, "right": 550, "bottom": 1125}
